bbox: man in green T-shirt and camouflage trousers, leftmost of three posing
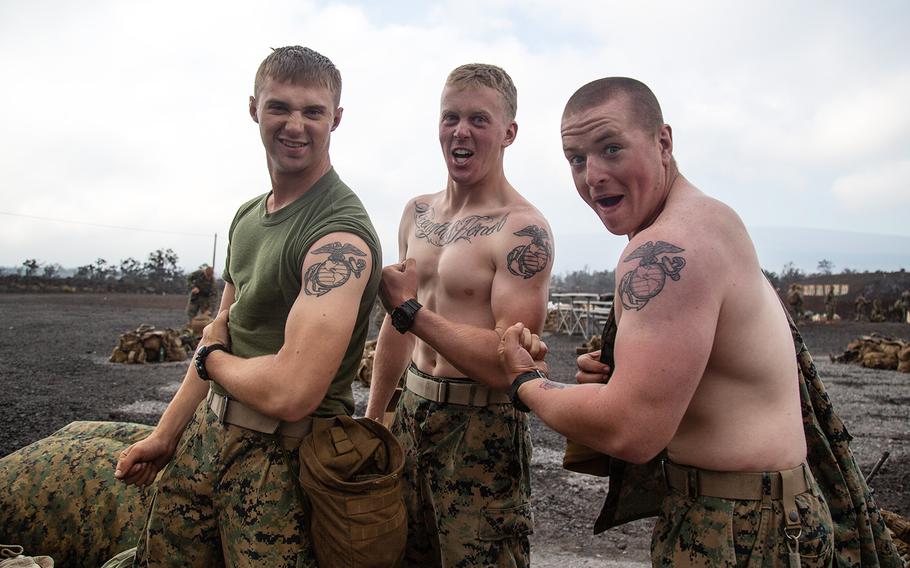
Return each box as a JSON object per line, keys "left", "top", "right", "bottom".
{"left": 115, "top": 46, "right": 382, "bottom": 567}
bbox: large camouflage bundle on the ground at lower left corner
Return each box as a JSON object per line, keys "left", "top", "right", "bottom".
{"left": 0, "top": 422, "right": 153, "bottom": 568}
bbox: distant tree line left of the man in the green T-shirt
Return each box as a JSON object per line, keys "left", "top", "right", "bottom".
{"left": 0, "top": 248, "right": 187, "bottom": 294}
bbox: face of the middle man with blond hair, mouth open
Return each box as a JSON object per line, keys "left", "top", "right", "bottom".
{"left": 439, "top": 85, "right": 518, "bottom": 185}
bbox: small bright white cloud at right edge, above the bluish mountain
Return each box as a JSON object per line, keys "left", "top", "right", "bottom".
{"left": 831, "top": 160, "right": 910, "bottom": 211}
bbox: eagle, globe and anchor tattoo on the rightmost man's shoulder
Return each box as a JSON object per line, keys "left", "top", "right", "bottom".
{"left": 619, "top": 241, "right": 686, "bottom": 310}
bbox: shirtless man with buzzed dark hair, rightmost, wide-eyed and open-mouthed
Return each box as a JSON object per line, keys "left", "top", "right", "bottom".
{"left": 500, "top": 78, "right": 832, "bottom": 566}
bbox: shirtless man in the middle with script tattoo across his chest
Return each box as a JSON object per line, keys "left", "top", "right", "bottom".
{"left": 367, "top": 64, "right": 553, "bottom": 567}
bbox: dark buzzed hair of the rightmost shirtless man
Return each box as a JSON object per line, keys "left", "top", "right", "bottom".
{"left": 562, "top": 77, "right": 664, "bottom": 133}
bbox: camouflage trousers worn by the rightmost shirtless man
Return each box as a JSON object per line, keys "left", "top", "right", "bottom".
{"left": 651, "top": 464, "right": 834, "bottom": 568}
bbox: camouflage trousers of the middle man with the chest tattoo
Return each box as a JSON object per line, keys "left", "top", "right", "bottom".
{"left": 392, "top": 384, "right": 533, "bottom": 568}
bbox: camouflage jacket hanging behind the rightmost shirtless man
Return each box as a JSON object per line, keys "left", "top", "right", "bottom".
{"left": 594, "top": 308, "right": 904, "bottom": 568}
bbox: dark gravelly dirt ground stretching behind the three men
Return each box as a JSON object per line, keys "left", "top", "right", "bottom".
{"left": 0, "top": 294, "right": 910, "bottom": 567}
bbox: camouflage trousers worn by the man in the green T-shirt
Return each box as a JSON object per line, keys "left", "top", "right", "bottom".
{"left": 136, "top": 402, "right": 316, "bottom": 568}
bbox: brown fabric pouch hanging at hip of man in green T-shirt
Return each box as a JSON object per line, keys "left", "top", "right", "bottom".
{"left": 300, "top": 416, "right": 407, "bottom": 568}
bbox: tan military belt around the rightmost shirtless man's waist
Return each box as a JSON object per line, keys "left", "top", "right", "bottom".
{"left": 662, "top": 460, "right": 812, "bottom": 501}
